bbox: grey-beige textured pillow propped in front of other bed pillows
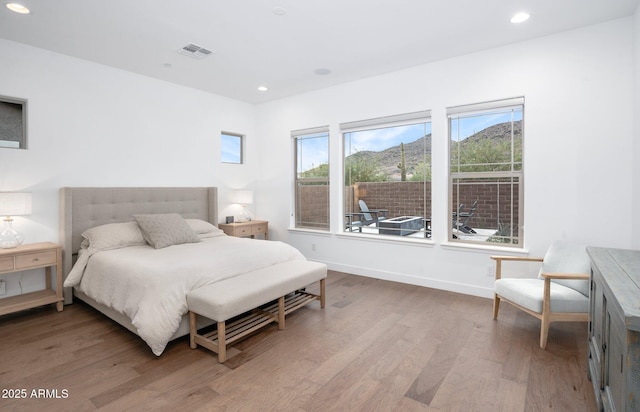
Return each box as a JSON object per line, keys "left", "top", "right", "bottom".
{"left": 133, "top": 213, "right": 200, "bottom": 249}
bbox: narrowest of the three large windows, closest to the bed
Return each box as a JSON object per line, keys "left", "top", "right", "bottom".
{"left": 291, "top": 127, "right": 329, "bottom": 231}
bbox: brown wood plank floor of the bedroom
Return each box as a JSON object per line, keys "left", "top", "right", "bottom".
{"left": 0, "top": 272, "right": 596, "bottom": 412}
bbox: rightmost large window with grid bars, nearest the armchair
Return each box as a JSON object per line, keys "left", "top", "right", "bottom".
{"left": 447, "top": 98, "right": 524, "bottom": 247}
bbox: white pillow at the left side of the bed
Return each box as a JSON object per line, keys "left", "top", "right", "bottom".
{"left": 81, "top": 222, "right": 147, "bottom": 251}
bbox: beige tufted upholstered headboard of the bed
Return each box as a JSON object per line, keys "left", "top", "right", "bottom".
{"left": 60, "top": 187, "right": 218, "bottom": 303}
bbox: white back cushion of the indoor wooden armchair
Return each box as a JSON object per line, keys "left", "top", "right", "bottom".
{"left": 540, "top": 241, "right": 591, "bottom": 297}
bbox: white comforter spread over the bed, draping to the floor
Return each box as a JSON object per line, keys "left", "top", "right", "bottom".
{"left": 65, "top": 236, "right": 304, "bottom": 356}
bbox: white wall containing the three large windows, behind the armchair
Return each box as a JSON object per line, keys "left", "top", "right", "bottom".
{"left": 256, "top": 18, "right": 637, "bottom": 296}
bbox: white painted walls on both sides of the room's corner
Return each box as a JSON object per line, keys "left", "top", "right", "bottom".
{"left": 0, "top": 13, "right": 640, "bottom": 296}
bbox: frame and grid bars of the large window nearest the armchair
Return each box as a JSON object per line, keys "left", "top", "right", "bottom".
{"left": 447, "top": 97, "right": 525, "bottom": 249}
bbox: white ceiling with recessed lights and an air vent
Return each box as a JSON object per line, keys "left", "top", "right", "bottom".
{"left": 0, "top": 0, "right": 640, "bottom": 103}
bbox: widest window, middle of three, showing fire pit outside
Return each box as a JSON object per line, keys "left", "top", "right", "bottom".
{"left": 340, "top": 111, "right": 431, "bottom": 239}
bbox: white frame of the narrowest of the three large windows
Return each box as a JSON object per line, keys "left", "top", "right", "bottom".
{"left": 291, "top": 126, "right": 331, "bottom": 232}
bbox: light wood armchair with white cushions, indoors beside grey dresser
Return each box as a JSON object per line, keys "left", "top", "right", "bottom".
{"left": 491, "top": 242, "right": 591, "bottom": 349}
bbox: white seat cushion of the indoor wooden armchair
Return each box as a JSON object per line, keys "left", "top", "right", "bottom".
{"left": 495, "top": 278, "right": 589, "bottom": 313}
